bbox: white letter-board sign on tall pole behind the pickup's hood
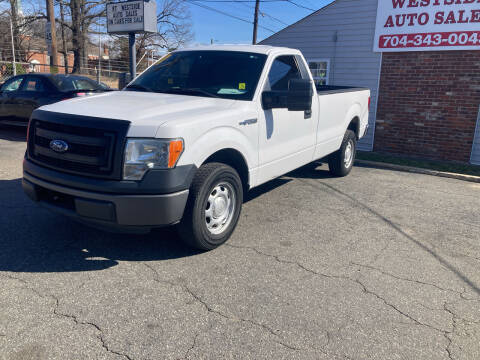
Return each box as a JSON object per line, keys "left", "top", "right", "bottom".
{"left": 107, "top": 0, "right": 157, "bottom": 34}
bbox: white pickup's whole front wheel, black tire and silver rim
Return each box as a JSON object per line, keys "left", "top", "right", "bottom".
{"left": 178, "top": 163, "right": 243, "bottom": 250}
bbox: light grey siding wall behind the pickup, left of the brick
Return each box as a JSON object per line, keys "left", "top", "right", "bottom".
{"left": 261, "top": 0, "right": 381, "bottom": 150}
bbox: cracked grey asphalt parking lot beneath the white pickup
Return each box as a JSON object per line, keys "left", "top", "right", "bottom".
{"left": 0, "top": 128, "right": 480, "bottom": 360}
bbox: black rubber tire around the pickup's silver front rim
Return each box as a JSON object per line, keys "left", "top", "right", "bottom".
{"left": 177, "top": 163, "right": 243, "bottom": 250}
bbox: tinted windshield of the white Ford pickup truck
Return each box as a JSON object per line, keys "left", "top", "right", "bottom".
{"left": 126, "top": 50, "right": 267, "bottom": 100}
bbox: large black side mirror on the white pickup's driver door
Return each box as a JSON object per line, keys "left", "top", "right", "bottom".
{"left": 262, "top": 79, "right": 313, "bottom": 111}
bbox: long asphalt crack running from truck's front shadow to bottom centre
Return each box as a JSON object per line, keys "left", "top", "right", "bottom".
{"left": 143, "top": 263, "right": 306, "bottom": 351}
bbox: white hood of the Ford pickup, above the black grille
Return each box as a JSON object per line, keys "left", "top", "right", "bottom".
{"left": 41, "top": 91, "right": 235, "bottom": 137}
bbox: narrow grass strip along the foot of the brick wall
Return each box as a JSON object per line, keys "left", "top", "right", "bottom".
{"left": 357, "top": 151, "right": 480, "bottom": 176}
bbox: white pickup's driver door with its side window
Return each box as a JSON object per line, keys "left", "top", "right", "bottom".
{"left": 258, "top": 55, "right": 317, "bottom": 184}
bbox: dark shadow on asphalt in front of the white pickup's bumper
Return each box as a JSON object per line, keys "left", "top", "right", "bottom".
{"left": 0, "top": 179, "right": 199, "bottom": 272}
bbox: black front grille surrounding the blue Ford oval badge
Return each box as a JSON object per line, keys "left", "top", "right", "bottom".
{"left": 28, "top": 113, "right": 128, "bottom": 179}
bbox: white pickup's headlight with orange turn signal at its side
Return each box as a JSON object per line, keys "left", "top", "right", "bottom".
{"left": 123, "top": 139, "right": 183, "bottom": 180}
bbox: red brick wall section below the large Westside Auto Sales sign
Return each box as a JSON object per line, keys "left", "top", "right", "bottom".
{"left": 374, "top": 51, "right": 480, "bottom": 162}
